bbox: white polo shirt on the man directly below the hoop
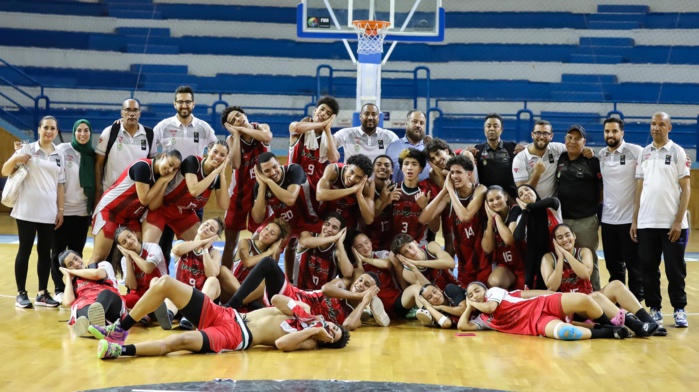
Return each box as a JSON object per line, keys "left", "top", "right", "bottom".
{"left": 335, "top": 126, "right": 398, "bottom": 162}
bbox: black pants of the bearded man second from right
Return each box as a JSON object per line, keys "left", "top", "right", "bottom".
{"left": 602, "top": 223, "right": 644, "bottom": 301}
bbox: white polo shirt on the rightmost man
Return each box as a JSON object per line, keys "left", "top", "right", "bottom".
{"left": 636, "top": 140, "right": 689, "bottom": 229}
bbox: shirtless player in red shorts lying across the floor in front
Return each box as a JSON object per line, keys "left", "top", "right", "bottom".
{"left": 89, "top": 276, "right": 349, "bottom": 359}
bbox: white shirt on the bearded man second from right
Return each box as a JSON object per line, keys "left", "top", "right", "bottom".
{"left": 597, "top": 140, "right": 643, "bottom": 225}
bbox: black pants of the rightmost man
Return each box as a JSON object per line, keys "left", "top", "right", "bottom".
{"left": 638, "top": 229, "right": 688, "bottom": 309}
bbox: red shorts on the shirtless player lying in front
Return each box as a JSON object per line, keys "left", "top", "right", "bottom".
{"left": 197, "top": 297, "right": 252, "bottom": 353}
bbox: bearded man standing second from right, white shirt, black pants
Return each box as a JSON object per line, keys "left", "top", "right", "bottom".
{"left": 599, "top": 118, "right": 644, "bottom": 301}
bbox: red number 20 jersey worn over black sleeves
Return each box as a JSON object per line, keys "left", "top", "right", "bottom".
{"left": 251, "top": 163, "right": 318, "bottom": 231}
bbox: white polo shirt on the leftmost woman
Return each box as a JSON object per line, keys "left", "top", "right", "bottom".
{"left": 10, "top": 142, "right": 66, "bottom": 224}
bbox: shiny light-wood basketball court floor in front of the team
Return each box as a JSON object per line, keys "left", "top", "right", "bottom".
{"left": 0, "top": 215, "right": 699, "bottom": 391}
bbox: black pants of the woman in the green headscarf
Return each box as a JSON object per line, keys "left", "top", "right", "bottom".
{"left": 51, "top": 215, "right": 92, "bottom": 293}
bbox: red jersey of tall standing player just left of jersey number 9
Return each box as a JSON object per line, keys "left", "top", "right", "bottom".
{"left": 228, "top": 127, "right": 269, "bottom": 213}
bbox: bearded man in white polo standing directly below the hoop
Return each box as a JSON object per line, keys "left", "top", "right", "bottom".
{"left": 335, "top": 103, "right": 398, "bottom": 162}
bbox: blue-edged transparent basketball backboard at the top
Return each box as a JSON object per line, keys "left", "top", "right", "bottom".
{"left": 296, "top": 0, "right": 444, "bottom": 42}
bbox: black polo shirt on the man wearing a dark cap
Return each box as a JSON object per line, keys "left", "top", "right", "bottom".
{"left": 556, "top": 152, "right": 603, "bottom": 219}
